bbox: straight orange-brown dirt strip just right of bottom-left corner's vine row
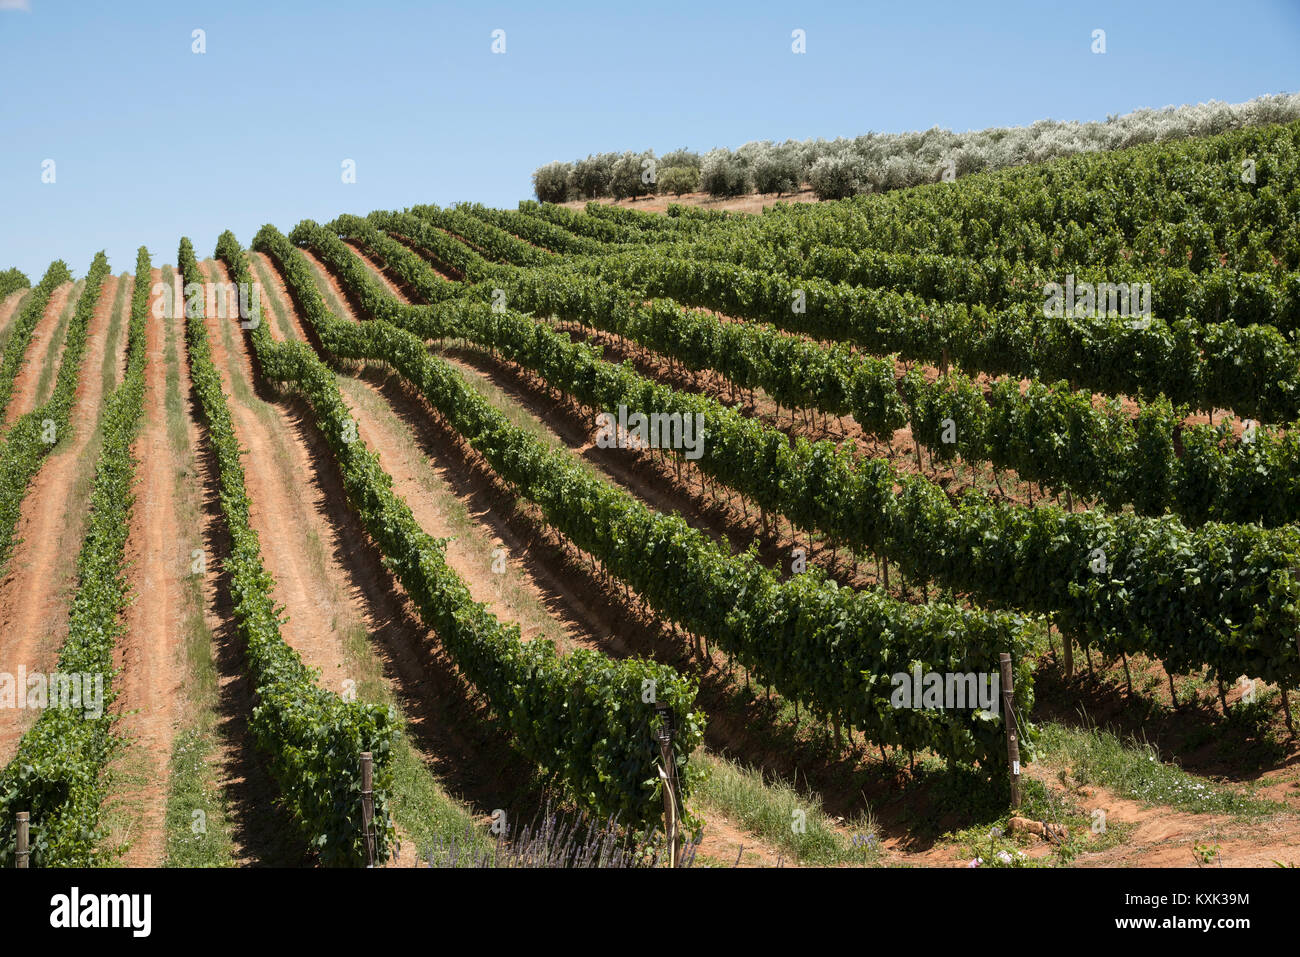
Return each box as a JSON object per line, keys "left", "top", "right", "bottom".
{"left": 113, "top": 269, "right": 191, "bottom": 866}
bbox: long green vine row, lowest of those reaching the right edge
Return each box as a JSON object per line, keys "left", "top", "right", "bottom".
{"left": 294, "top": 222, "right": 1300, "bottom": 696}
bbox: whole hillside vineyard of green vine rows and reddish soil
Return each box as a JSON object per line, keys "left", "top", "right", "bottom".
{"left": 0, "top": 115, "right": 1300, "bottom": 867}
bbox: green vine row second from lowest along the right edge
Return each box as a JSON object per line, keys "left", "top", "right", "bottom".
{"left": 358, "top": 216, "right": 1300, "bottom": 525}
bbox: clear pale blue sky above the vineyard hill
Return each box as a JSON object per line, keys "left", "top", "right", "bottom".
{"left": 0, "top": 0, "right": 1300, "bottom": 282}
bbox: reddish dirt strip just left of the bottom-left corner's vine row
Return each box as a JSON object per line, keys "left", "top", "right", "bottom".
{"left": 0, "top": 277, "right": 117, "bottom": 765}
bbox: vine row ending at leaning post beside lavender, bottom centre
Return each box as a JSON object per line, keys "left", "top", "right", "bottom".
{"left": 236, "top": 226, "right": 703, "bottom": 827}
